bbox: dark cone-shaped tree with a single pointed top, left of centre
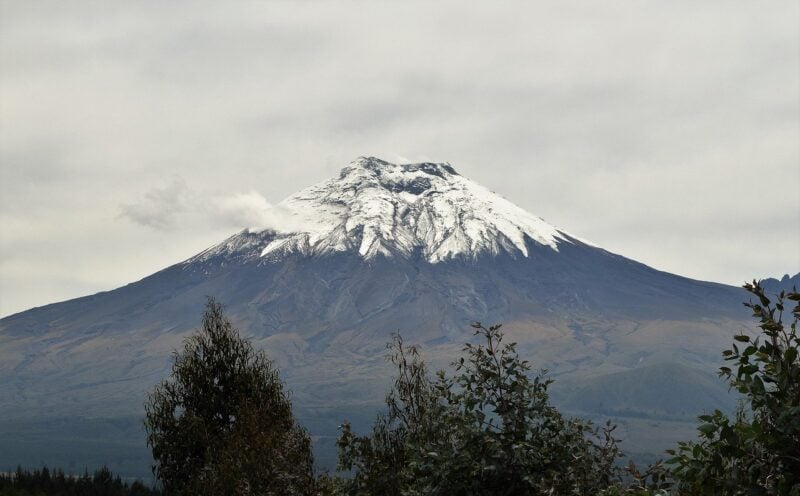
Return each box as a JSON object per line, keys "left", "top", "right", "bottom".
{"left": 145, "top": 299, "right": 314, "bottom": 496}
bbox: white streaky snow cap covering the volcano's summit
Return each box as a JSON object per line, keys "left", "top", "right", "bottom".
{"left": 199, "top": 157, "right": 573, "bottom": 263}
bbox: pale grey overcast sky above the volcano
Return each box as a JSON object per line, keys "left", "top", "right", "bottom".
{"left": 0, "top": 0, "right": 800, "bottom": 315}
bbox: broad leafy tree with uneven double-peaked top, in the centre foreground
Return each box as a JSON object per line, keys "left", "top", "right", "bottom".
{"left": 339, "top": 324, "right": 636, "bottom": 496}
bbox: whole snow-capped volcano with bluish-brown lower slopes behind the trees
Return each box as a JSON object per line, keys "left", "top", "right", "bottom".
{"left": 0, "top": 158, "right": 747, "bottom": 474}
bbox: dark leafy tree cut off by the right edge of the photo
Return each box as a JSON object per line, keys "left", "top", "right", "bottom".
{"left": 670, "top": 281, "right": 800, "bottom": 496}
